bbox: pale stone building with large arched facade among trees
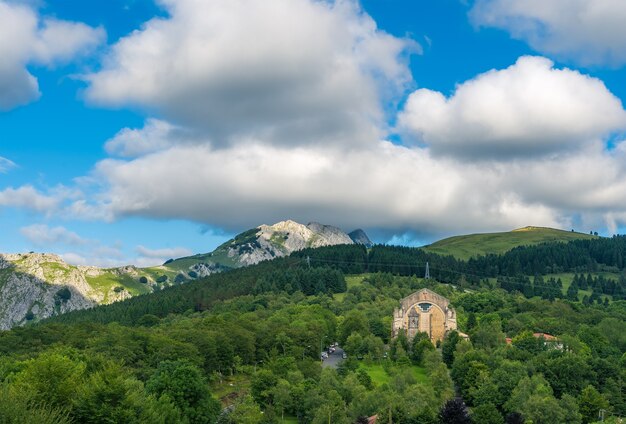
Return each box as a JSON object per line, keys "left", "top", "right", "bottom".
{"left": 392, "top": 289, "right": 456, "bottom": 343}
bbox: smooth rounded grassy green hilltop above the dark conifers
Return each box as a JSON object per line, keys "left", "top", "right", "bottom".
{"left": 424, "top": 227, "right": 598, "bottom": 260}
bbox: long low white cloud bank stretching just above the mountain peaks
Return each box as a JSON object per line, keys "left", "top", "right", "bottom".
{"left": 90, "top": 142, "right": 565, "bottom": 234}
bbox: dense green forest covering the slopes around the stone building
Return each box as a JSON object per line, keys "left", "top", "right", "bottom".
{"left": 0, "top": 238, "right": 626, "bottom": 424}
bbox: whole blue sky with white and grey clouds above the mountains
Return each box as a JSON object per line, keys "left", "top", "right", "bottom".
{"left": 0, "top": 0, "right": 626, "bottom": 266}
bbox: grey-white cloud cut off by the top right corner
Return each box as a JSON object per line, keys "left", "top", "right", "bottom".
{"left": 470, "top": 0, "right": 626, "bottom": 65}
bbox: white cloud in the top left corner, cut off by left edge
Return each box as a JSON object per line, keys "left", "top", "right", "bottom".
{"left": 0, "top": 0, "right": 105, "bottom": 111}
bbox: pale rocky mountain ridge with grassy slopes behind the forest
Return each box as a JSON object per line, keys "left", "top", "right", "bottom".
{"left": 0, "top": 221, "right": 369, "bottom": 330}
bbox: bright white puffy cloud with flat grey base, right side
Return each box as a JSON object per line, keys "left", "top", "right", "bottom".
{"left": 399, "top": 56, "right": 626, "bottom": 158}
